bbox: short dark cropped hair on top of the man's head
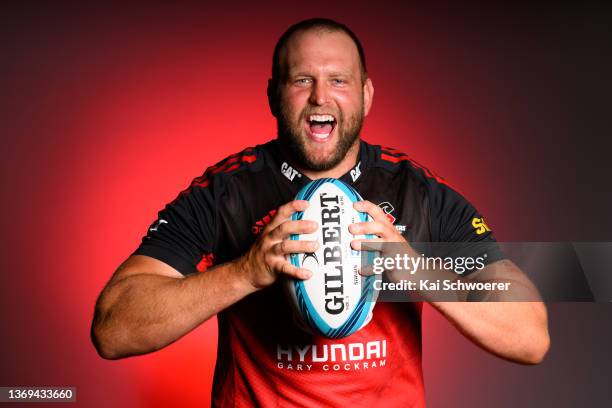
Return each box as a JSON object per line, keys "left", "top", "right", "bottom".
{"left": 272, "top": 18, "right": 368, "bottom": 84}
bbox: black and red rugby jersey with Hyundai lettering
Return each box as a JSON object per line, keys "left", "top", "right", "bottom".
{"left": 134, "top": 141, "right": 501, "bottom": 407}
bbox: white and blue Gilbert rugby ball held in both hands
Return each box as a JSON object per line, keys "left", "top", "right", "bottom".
{"left": 287, "top": 178, "right": 377, "bottom": 339}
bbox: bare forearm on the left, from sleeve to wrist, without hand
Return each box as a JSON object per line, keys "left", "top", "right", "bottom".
{"left": 92, "top": 260, "right": 255, "bottom": 359}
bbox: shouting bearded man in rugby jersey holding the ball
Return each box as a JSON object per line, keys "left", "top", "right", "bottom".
{"left": 92, "top": 19, "right": 549, "bottom": 407}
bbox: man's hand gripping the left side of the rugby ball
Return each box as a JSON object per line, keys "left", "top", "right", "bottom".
{"left": 239, "top": 200, "right": 319, "bottom": 289}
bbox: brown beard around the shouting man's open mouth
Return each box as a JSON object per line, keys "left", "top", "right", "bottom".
{"left": 276, "top": 100, "right": 364, "bottom": 171}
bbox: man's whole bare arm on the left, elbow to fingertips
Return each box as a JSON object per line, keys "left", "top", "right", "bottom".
{"left": 91, "top": 201, "right": 316, "bottom": 359}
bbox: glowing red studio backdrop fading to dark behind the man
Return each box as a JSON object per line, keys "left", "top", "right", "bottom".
{"left": 0, "top": 1, "right": 612, "bottom": 407}
